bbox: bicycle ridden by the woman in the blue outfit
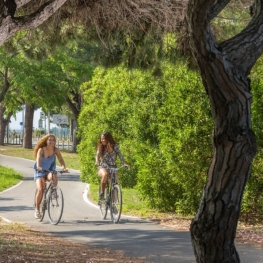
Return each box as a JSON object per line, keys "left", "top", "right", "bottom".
{"left": 33, "top": 170, "right": 65, "bottom": 225}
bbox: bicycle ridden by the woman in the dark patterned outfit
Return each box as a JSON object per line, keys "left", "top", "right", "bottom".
{"left": 98, "top": 165, "right": 128, "bottom": 224}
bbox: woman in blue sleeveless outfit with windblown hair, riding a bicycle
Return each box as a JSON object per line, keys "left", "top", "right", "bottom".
{"left": 34, "top": 134, "right": 68, "bottom": 219}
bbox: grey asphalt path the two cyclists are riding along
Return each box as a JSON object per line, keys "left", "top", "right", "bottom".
{"left": 0, "top": 155, "right": 263, "bottom": 263}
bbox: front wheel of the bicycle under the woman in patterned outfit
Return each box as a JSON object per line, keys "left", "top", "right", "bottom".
{"left": 110, "top": 184, "right": 122, "bottom": 224}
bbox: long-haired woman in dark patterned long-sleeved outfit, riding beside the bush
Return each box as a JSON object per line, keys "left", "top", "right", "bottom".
{"left": 95, "top": 132, "right": 129, "bottom": 200}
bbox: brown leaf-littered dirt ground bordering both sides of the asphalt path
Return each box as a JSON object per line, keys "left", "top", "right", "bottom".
{"left": 0, "top": 217, "right": 263, "bottom": 263}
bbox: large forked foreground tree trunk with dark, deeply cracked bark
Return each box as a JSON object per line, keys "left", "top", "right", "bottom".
{"left": 187, "top": 0, "right": 263, "bottom": 263}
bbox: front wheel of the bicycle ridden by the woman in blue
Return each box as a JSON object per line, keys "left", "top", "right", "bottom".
{"left": 48, "top": 186, "right": 64, "bottom": 225}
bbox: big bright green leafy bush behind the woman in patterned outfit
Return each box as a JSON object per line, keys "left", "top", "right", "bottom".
{"left": 78, "top": 62, "right": 212, "bottom": 216}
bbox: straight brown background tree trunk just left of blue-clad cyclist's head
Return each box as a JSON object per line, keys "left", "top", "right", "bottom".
{"left": 23, "top": 103, "right": 35, "bottom": 149}
